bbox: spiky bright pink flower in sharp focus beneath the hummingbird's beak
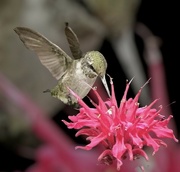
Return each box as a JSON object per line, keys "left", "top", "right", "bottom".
{"left": 63, "top": 79, "right": 178, "bottom": 170}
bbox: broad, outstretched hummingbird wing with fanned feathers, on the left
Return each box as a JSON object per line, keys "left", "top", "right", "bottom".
{"left": 14, "top": 27, "right": 73, "bottom": 80}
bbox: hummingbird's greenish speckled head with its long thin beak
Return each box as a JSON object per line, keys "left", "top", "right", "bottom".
{"left": 85, "top": 51, "right": 110, "bottom": 97}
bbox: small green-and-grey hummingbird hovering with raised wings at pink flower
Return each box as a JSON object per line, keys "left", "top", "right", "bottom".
{"left": 14, "top": 23, "right": 110, "bottom": 105}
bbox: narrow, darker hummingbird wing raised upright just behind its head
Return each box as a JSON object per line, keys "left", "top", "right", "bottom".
{"left": 65, "top": 23, "right": 82, "bottom": 59}
